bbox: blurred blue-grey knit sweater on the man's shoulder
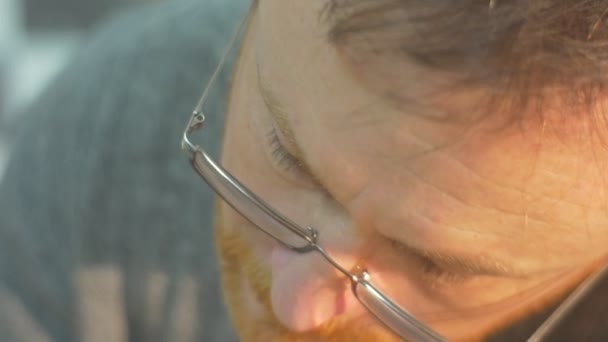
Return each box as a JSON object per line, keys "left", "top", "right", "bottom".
{"left": 0, "top": 0, "right": 247, "bottom": 342}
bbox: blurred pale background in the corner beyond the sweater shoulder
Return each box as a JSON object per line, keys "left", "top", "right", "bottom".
{"left": 0, "top": 0, "right": 161, "bottom": 178}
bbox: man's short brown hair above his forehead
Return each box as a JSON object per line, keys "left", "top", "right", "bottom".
{"left": 325, "top": 0, "right": 608, "bottom": 125}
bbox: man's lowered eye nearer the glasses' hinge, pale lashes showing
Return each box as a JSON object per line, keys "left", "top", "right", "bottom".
{"left": 265, "top": 125, "right": 319, "bottom": 188}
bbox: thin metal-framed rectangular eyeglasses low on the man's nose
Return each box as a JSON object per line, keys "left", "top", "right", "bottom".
{"left": 181, "top": 4, "right": 608, "bottom": 342}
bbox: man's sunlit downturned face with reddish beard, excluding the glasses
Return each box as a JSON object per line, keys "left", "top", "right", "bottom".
{"left": 217, "top": 0, "right": 608, "bottom": 341}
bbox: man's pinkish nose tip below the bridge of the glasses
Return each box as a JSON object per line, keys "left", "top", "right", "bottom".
{"left": 271, "top": 247, "right": 362, "bottom": 332}
